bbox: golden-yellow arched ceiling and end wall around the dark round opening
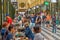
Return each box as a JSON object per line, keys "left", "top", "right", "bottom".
{"left": 17, "top": 0, "right": 44, "bottom": 9}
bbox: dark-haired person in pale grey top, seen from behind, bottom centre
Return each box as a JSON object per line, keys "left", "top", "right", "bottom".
{"left": 33, "top": 26, "right": 44, "bottom": 40}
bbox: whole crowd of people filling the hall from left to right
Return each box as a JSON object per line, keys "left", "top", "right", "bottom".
{"left": 1, "top": 12, "right": 57, "bottom": 40}
